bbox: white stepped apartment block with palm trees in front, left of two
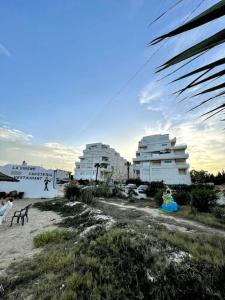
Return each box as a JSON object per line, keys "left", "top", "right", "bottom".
{"left": 74, "top": 143, "right": 127, "bottom": 181}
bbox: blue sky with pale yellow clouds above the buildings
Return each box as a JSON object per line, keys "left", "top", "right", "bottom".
{"left": 0, "top": 0, "right": 225, "bottom": 172}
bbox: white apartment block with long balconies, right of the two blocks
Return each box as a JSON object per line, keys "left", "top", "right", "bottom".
{"left": 133, "top": 134, "right": 191, "bottom": 184}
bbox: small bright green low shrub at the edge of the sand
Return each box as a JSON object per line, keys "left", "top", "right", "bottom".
{"left": 33, "top": 229, "right": 72, "bottom": 248}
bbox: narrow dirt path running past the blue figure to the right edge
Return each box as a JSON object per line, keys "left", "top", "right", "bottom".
{"left": 98, "top": 200, "right": 225, "bottom": 238}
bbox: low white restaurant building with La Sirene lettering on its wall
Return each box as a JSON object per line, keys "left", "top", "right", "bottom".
{"left": 0, "top": 161, "right": 69, "bottom": 198}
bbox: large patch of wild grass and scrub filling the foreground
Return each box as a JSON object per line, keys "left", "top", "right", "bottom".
{"left": 1, "top": 226, "right": 225, "bottom": 300}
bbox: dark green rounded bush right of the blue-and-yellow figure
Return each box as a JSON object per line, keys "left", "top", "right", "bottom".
{"left": 191, "top": 188, "right": 217, "bottom": 212}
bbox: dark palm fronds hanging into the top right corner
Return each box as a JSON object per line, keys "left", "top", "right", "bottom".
{"left": 151, "top": 0, "right": 225, "bottom": 121}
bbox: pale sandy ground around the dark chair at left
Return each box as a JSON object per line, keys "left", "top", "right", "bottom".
{"left": 0, "top": 199, "right": 61, "bottom": 275}
